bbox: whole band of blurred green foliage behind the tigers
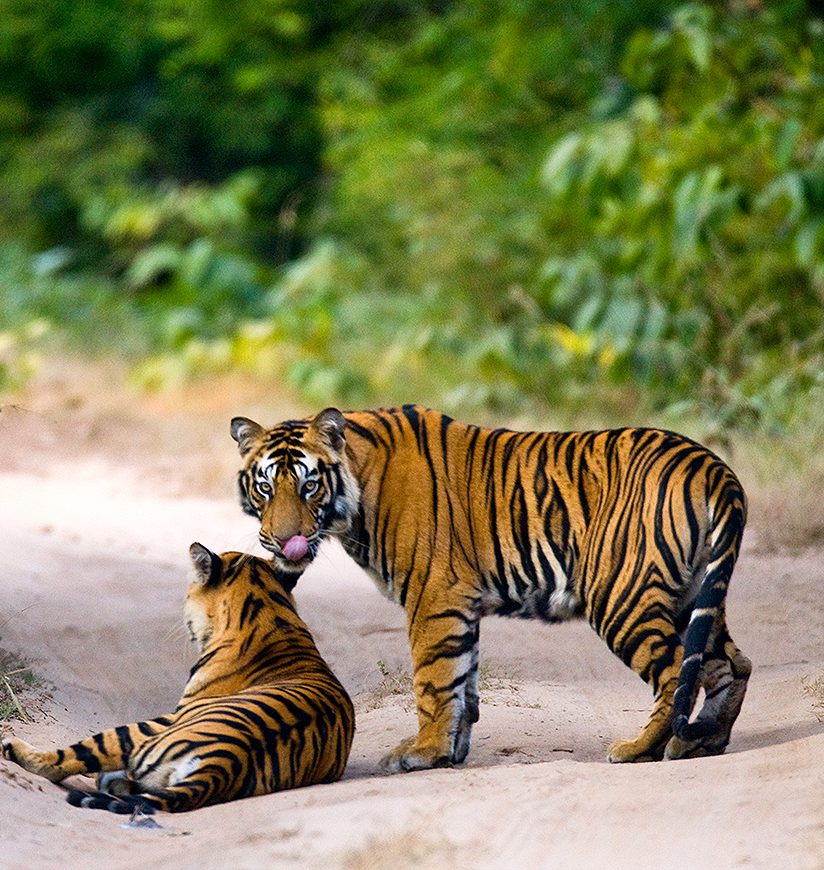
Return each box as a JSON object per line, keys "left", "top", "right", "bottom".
{"left": 0, "top": 0, "right": 824, "bottom": 430}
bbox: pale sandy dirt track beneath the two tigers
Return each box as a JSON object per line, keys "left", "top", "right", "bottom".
{"left": 0, "top": 382, "right": 824, "bottom": 870}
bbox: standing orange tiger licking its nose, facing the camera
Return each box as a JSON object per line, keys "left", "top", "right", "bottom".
{"left": 231, "top": 405, "right": 751, "bottom": 772}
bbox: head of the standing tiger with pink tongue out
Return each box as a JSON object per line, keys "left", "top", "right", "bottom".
{"left": 232, "top": 408, "right": 360, "bottom": 574}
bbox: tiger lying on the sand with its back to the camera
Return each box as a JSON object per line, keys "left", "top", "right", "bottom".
{"left": 2, "top": 544, "right": 355, "bottom": 813}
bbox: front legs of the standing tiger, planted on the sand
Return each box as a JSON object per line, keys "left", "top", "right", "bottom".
{"left": 381, "top": 608, "right": 478, "bottom": 773}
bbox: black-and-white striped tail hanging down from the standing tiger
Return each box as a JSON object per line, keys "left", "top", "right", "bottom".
{"left": 672, "top": 464, "right": 747, "bottom": 741}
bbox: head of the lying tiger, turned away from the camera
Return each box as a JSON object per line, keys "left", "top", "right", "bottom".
{"left": 183, "top": 542, "right": 302, "bottom": 652}
